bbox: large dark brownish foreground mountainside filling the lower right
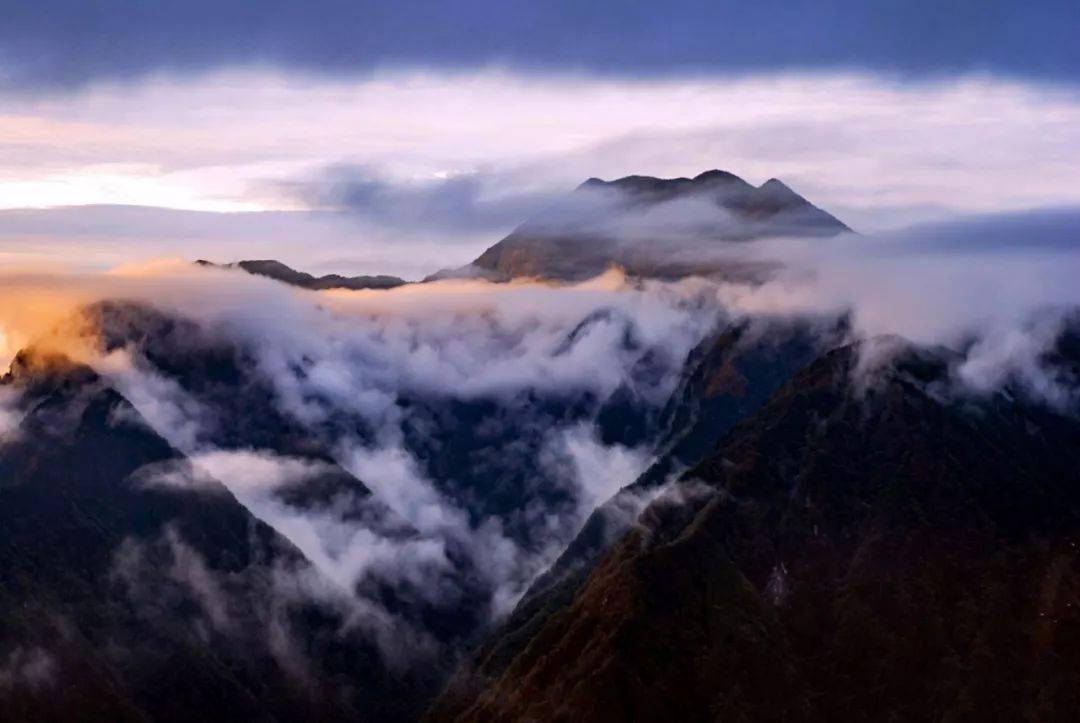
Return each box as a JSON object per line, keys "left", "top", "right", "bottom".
{"left": 429, "top": 346, "right": 1080, "bottom": 721}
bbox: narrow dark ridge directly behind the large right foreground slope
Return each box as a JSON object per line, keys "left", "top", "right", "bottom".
{"left": 432, "top": 311, "right": 846, "bottom": 696}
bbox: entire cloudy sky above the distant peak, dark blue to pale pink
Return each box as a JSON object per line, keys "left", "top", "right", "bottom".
{"left": 0, "top": 0, "right": 1080, "bottom": 278}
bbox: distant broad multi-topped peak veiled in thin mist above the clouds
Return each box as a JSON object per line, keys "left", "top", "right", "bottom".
{"left": 464, "top": 169, "right": 851, "bottom": 281}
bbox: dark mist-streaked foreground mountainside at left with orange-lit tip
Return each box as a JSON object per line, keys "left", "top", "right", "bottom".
{"left": 0, "top": 352, "right": 438, "bottom": 721}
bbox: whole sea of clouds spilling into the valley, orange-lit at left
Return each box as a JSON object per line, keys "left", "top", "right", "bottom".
{"left": 0, "top": 203, "right": 1080, "bottom": 665}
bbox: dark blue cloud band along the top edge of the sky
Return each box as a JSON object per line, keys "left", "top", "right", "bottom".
{"left": 0, "top": 0, "right": 1080, "bottom": 90}
